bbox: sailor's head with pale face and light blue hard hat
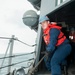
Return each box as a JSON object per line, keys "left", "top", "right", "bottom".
{"left": 39, "top": 16, "right": 50, "bottom": 29}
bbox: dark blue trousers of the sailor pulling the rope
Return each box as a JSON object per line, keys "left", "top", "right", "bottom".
{"left": 44, "top": 44, "right": 71, "bottom": 75}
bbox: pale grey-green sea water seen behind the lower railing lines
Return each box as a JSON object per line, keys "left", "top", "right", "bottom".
{"left": 0, "top": 53, "right": 35, "bottom": 75}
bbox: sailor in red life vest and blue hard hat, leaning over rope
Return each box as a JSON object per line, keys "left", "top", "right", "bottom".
{"left": 39, "top": 16, "right": 71, "bottom": 75}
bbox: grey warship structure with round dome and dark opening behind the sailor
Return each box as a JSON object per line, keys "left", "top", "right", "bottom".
{"left": 0, "top": 0, "right": 75, "bottom": 75}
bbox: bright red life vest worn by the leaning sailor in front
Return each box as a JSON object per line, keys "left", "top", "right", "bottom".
{"left": 43, "top": 24, "right": 66, "bottom": 46}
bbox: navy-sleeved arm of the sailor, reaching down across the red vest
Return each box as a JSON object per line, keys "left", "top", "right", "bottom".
{"left": 46, "top": 28, "right": 60, "bottom": 51}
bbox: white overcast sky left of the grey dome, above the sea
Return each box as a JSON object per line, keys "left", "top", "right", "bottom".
{"left": 0, "top": 0, "right": 37, "bottom": 53}
